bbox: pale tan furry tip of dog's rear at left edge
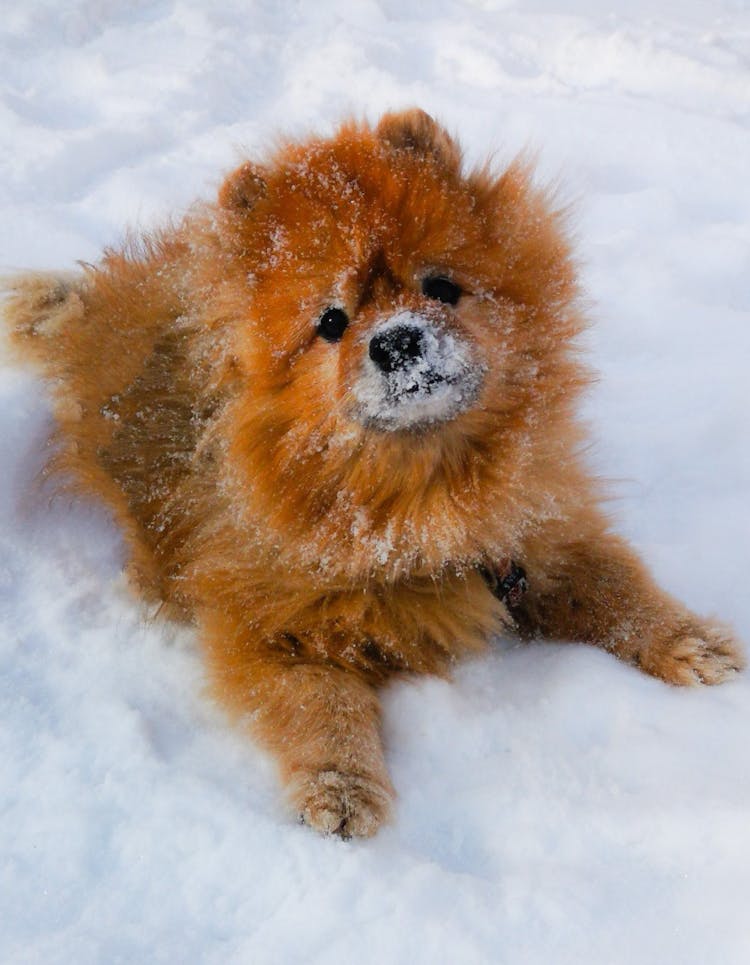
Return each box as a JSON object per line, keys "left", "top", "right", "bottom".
{"left": 0, "top": 272, "right": 86, "bottom": 375}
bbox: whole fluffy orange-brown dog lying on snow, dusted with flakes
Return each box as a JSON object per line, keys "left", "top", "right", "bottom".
{"left": 6, "top": 110, "right": 742, "bottom": 837}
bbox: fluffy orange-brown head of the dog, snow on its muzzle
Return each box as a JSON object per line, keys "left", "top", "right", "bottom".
{"left": 209, "top": 111, "right": 579, "bottom": 564}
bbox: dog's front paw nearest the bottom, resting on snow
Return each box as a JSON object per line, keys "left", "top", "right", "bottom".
{"left": 289, "top": 770, "right": 393, "bottom": 838}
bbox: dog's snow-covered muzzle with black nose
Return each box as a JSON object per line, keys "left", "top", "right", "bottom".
{"left": 352, "top": 312, "right": 482, "bottom": 432}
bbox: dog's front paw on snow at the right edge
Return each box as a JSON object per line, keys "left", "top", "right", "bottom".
{"left": 639, "top": 622, "right": 745, "bottom": 687}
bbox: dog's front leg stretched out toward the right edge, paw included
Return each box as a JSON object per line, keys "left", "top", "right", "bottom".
{"left": 515, "top": 518, "right": 744, "bottom": 686}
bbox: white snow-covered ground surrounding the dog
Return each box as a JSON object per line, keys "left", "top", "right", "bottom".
{"left": 0, "top": 0, "right": 750, "bottom": 965}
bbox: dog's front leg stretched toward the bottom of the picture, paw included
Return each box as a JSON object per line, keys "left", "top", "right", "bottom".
{"left": 207, "top": 616, "right": 393, "bottom": 837}
